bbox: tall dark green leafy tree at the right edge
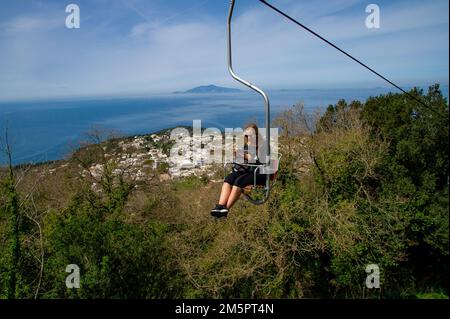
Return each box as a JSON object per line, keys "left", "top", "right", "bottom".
{"left": 363, "top": 84, "right": 449, "bottom": 294}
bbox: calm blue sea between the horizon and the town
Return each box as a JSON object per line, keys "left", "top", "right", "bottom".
{"left": 0, "top": 86, "right": 448, "bottom": 168}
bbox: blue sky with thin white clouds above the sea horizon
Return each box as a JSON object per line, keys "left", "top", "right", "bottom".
{"left": 0, "top": 0, "right": 449, "bottom": 100}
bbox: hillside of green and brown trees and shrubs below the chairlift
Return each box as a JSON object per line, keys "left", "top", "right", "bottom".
{"left": 0, "top": 85, "right": 449, "bottom": 298}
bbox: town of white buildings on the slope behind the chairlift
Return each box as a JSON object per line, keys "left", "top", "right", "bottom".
{"left": 26, "top": 129, "right": 311, "bottom": 187}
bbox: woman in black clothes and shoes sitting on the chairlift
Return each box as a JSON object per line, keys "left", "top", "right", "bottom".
{"left": 211, "top": 124, "right": 266, "bottom": 217}
